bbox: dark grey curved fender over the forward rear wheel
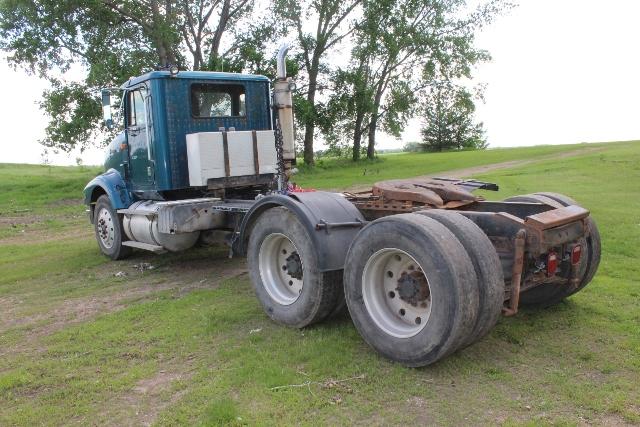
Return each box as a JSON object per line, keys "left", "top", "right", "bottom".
{"left": 235, "top": 191, "right": 366, "bottom": 271}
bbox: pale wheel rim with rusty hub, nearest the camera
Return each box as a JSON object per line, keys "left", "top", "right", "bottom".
{"left": 362, "top": 248, "right": 431, "bottom": 338}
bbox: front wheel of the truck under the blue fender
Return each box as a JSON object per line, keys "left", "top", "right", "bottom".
{"left": 93, "top": 194, "right": 131, "bottom": 260}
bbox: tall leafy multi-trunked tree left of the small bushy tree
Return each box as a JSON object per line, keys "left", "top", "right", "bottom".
{"left": 328, "top": 0, "right": 510, "bottom": 160}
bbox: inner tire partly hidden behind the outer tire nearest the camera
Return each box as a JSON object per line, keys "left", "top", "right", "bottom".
{"left": 417, "top": 209, "right": 504, "bottom": 347}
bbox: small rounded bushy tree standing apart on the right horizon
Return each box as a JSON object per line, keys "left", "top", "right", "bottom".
{"left": 421, "top": 84, "right": 487, "bottom": 151}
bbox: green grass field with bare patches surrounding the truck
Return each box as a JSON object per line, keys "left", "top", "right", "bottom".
{"left": 0, "top": 142, "right": 640, "bottom": 426}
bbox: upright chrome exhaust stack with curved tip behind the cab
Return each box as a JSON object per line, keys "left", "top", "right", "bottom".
{"left": 273, "top": 43, "right": 296, "bottom": 164}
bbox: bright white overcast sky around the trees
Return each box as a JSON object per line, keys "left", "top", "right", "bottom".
{"left": 0, "top": 0, "right": 640, "bottom": 164}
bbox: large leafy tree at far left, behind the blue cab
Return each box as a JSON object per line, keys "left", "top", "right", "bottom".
{"left": 0, "top": 0, "right": 266, "bottom": 152}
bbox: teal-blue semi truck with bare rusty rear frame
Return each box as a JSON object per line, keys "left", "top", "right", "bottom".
{"left": 84, "top": 45, "right": 601, "bottom": 367}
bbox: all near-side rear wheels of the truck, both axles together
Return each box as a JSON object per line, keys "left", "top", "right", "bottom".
{"left": 247, "top": 208, "right": 504, "bottom": 366}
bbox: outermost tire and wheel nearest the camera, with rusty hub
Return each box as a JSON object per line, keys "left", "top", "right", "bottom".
{"left": 344, "top": 214, "right": 478, "bottom": 367}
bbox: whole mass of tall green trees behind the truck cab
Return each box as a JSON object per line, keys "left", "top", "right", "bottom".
{"left": 0, "top": 0, "right": 510, "bottom": 164}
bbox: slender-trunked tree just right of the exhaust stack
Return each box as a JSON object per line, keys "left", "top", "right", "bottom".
{"left": 274, "top": 0, "right": 362, "bottom": 164}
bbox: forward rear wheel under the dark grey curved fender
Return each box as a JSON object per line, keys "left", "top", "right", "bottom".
{"left": 247, "top": 208, "right": 341, "bottom": 328}
